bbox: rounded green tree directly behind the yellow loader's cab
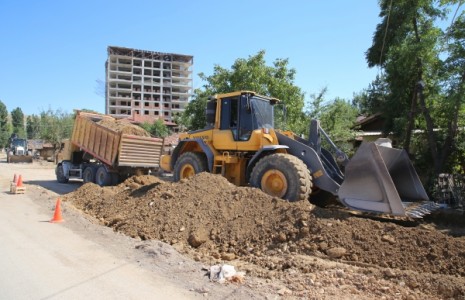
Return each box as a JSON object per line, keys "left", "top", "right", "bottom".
{"left": 180, "top": 50, "right": 308, "bottom": 134}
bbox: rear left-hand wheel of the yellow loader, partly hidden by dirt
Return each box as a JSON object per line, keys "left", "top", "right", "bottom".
{"left": 173, "top": 152, "right": 208, "bottom": 181}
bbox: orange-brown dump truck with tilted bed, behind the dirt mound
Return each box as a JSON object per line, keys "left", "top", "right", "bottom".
{"left": 55, "top": 111, "right": 163, "bottom": 186}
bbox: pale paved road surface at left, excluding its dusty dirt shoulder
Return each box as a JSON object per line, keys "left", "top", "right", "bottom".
{"left": 0, "top": 155, "right": 198, "bottom": 299}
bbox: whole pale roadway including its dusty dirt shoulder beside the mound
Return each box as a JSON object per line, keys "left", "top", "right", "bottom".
{"left": 0, "top": 156, "right": 261, "bottom": 299}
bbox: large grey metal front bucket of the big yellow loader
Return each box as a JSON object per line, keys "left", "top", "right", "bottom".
{"left": 338, "top": 142, "right": 428, "bottom": 216}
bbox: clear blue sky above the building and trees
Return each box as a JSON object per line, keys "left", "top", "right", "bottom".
{"left": 0, "top": 0, "right": 379, "bottom": 115}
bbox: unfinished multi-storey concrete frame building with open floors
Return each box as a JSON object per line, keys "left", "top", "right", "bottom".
{"left": 105, "top": 46, "right": 194, "bottom": 124}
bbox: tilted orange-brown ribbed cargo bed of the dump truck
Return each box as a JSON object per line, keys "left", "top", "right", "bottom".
{"left": 71, "top": 112, "right": 163, "bottom": 168}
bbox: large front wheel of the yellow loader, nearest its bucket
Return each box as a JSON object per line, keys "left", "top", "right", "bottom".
{"left": 250, "top": 153, "right": 312, "bottom": 201}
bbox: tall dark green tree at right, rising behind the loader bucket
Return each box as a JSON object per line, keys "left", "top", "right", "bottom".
{"left": 366, "top": 0, "right": 465, "bottom": 174}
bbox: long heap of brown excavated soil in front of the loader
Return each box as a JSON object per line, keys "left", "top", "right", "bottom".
{"left": 63, "top": 173, "right": 465, "bottom": 299}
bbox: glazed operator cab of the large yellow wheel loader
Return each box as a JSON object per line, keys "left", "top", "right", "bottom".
{"left": 214, "top": 93, "right": 277, "bottom": 142}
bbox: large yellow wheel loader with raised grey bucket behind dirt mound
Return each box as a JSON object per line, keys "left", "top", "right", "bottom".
{"left": 160, "top": 91, "right": 435, "bottom": 217}
